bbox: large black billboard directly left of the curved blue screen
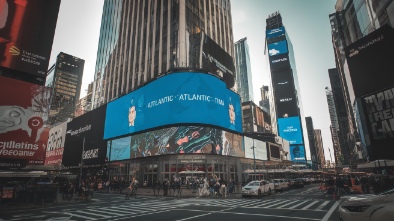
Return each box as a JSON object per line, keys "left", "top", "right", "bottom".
{"left": 62, "top": 105, "right": 107, "bottom": 167}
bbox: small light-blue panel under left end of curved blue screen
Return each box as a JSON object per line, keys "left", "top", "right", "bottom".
{"left": 107, "top": 137, "right": 131, "bottom": 161}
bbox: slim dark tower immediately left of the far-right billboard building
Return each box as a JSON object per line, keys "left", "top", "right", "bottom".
{"left": 326, "top": 84, "right": 348, "bottom": 166}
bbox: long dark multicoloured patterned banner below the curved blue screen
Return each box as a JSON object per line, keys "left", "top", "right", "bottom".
{"left": 130, "top": 126, "right": 223, "bottom": 158}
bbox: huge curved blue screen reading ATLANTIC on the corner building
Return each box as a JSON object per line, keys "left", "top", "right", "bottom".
{"left": 104, "top": 72, "right": 242, "bottom": 139}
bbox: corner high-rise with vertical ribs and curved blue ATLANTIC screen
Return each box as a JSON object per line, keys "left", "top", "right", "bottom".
{"left": 88, "top": 0, "right": 288, "bottom": 185}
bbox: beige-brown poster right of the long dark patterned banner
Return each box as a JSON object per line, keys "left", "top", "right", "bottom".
{"left": 222, "top": 131, "right": 245, "bottom": 157}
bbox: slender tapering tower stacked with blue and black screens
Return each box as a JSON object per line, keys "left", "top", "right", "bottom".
{"left": 266, "top": 12, "right": 311, "bottom": 164}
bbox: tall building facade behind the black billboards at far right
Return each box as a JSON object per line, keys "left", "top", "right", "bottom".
{"left": 329, "top": 0, "right": 394, "bottom": 164}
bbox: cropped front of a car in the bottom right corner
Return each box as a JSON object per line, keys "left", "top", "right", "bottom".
{"left": 338, "top": 186, "right": 394, "bottom": 221}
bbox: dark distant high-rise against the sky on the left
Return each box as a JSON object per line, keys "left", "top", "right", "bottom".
{"left": 45, "top": 52, "right": 85, "bottom": 126}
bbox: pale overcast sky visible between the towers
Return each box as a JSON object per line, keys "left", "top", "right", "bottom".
{"left": 50, "top": 0, "right": 336, "bottom": 160}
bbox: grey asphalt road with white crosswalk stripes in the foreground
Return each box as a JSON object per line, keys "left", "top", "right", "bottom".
{"left": 0, "top": 184, "right": 338, "bottom": 221}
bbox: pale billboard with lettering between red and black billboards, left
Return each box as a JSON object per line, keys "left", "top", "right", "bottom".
{"left": 45, "top": 122, "right": 67, "bottom": 165}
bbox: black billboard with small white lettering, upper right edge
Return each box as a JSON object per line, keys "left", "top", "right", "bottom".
{"left": 345, "top": 25, "right": 394, "bottom": 98}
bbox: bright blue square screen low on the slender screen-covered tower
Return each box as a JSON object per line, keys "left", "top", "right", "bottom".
{"left": 278, "top": 117, "right": 302, "bottom": 145}
